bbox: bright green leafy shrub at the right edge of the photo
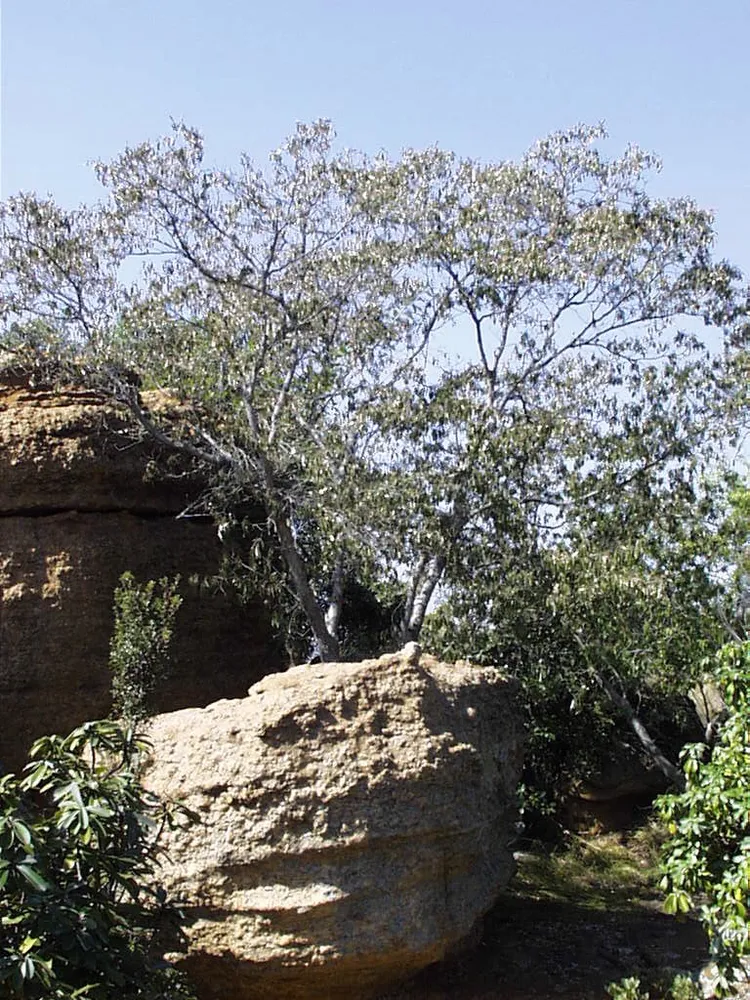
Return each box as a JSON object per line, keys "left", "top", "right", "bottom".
{"left": 659, "top": 642, "right": 750, "bottom": 995}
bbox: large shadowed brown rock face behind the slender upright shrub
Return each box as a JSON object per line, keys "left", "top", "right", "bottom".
{"left": 0, "top": 373, "right": 279, "bottom": 770}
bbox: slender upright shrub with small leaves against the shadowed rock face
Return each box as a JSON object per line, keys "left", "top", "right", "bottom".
{"left": 109, "top": 573, "right": 182, "bottom": 723}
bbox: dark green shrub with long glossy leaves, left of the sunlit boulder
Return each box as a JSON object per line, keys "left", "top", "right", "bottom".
{"left": 0, "top": 722, "right": 197, "bottom": 1000}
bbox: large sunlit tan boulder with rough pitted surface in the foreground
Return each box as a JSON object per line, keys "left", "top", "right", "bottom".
{"left": 145, "top": 651, "right": 521, "bottom": 1000}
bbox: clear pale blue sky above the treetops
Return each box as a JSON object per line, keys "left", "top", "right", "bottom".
{"left": 1, "top": 0, "right": 750, "bottom": 271}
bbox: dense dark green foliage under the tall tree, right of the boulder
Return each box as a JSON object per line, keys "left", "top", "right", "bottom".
{"left": 423, "top": 512, "right": 721, "bottom": 818}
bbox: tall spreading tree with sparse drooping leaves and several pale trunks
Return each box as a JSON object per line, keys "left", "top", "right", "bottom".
{"left": 0, "top": 122, "right": 742, "bottom": 659}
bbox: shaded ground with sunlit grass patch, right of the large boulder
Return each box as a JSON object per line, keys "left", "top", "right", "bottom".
{"left": 382, "top": 827, "right": 708, "bottom": 1000}
